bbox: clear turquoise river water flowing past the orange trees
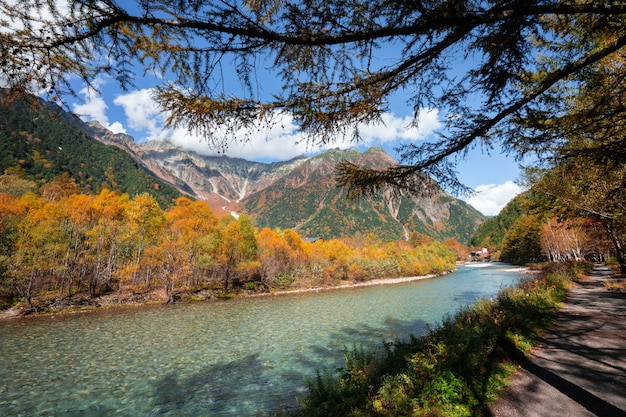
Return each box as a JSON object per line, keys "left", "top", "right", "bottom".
{"left": 0, "top": 264, "right": 520, "bottom": 417}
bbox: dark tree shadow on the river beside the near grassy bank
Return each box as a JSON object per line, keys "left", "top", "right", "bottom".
{"left": 149, "top": 318, "right": 428, "bottom": 416}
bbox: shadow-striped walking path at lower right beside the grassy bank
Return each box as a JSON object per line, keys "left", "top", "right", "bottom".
{"left": 491, "top": 266, "right": 626, "bottom": 417}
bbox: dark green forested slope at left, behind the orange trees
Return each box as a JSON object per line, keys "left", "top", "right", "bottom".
{"left": 0, "top": 91, "right": 180, "bottom": 207}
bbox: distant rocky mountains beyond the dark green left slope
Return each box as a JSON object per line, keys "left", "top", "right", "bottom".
{"left": 77, "top": 114, "right": 484, "bottom": 241}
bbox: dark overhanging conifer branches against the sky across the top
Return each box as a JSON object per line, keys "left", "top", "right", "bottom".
{"left": 0, "top": 0, "right": 626, "bottom": 193}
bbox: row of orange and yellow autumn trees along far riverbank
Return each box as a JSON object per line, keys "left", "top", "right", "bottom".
{"left": 0, "top": 175, "right": 456, "bottom": 309}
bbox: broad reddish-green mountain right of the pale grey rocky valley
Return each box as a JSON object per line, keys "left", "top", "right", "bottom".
{"left": 243, "top": 148, "right": 484, "bottom": 242}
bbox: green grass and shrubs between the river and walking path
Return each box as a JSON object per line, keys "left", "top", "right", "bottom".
{"left": 299, "top": 264, "right": 584, "bottom": 417}
